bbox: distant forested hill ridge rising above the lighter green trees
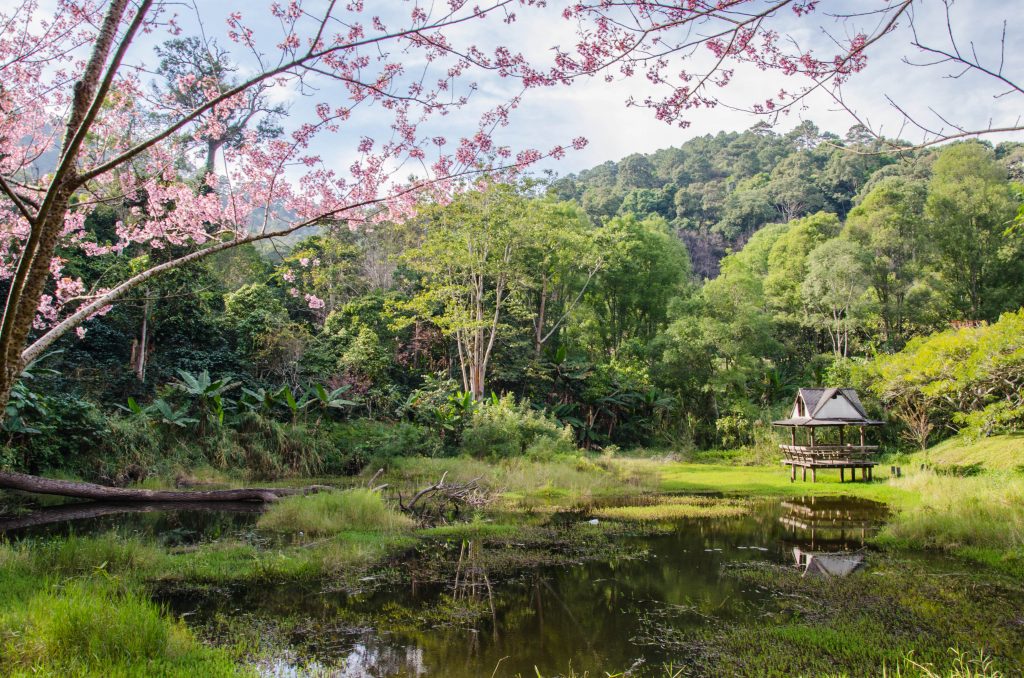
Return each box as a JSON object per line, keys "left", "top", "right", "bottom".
{"left": 551, "top": 122, "right": 1024, "bottom": 280}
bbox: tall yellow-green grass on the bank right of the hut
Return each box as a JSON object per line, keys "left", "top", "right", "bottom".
{"left": 882, "top": 471, "right": 1024, "bottom": 551}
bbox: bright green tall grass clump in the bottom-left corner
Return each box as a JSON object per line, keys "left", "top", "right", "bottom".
{"left": 0, "top": 580, "right": 240, "bottom": 676}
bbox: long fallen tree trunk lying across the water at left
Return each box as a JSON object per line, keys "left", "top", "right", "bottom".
{"left": 0, "top": 471, "right": 334, "bottom": 502}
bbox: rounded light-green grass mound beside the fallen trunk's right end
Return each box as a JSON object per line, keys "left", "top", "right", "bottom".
{"left": 258, "top": 489, "right": 413, "bottom": 535}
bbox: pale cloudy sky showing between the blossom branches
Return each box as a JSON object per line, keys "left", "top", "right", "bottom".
{"left": 9, "top": 0, "right": 1024, "bottom": 179}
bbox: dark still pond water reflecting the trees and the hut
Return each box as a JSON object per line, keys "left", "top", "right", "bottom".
{"left": 0, "top": 497, "right": 913, "bottom": 678}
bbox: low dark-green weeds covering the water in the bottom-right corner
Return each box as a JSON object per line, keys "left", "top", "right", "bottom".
{"left": 671, "top": 554, "right": 1024, "bottom": 677}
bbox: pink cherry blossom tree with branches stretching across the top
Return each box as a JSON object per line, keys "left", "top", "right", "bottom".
{"left": 0, "top": 0, "right": 1021, "bottom": 432}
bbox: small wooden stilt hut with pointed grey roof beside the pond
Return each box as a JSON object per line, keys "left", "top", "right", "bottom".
{"left": 772, "top": 388, "right": 882, "bottom": 482}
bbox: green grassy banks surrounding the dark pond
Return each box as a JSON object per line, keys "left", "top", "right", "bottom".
{"left": 0, "top": 443, "right": 1024, "bottom": 676}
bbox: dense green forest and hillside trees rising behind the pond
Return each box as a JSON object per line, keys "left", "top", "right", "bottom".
{"left": 6, "top": 123, "right": 1024, "bottom": 480}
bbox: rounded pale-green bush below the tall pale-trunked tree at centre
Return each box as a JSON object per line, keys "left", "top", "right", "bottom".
{"left": 462, "top": 394, "right": 575, "bottom": 459}
